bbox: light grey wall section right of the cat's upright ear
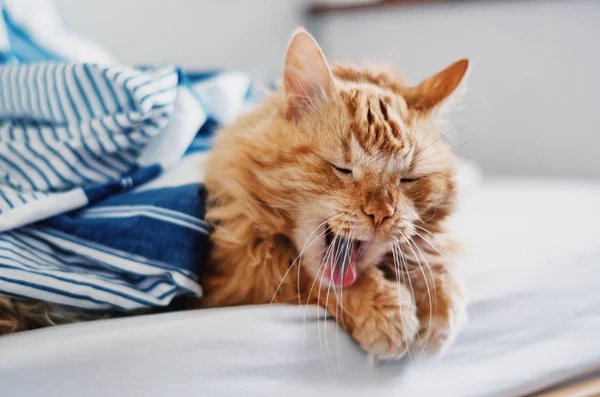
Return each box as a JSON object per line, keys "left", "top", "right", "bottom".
{"left": 314, "top": 0, "right": 600, "bottom": 177}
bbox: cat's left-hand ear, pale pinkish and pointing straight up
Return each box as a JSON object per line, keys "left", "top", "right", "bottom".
{"left": 283, "top": 28, "right": 335, "bottom": 120}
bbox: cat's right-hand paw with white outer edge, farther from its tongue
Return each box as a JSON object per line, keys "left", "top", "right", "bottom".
{"left": 410, "top": 297, "right": 467, "bottom": 356}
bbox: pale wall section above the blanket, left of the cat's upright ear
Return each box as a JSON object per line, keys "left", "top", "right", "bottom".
{"left": 55, "top": 0, "right": 305, "bottom": 73}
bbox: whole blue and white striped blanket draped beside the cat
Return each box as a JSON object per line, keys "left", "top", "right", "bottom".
{"left": 0, "top": 0, "right": 250, "bottom": 310}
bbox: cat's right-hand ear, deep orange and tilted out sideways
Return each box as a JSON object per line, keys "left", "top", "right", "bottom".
{"left": 405, "top": 59, "right": 469, "bottom": 111}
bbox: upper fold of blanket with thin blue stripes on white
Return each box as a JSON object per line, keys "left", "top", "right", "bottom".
{"left": 0, "top": 63, "right": 178, "bottom": 213}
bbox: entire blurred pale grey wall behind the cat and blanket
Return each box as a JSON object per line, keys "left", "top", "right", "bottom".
{"left": 57, "top": 0, "right": 600, "bottom": 179}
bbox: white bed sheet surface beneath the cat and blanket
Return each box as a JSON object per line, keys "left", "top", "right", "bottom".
{"left": 0, "top": 180, "right": 600, "bottom": 397}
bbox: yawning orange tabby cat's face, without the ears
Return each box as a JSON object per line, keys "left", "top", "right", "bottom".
{"left": 286, "top": 85, "right": 455, "bottom": 286}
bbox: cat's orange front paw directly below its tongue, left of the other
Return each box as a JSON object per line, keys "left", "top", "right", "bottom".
{"left": 351, "top": 283, "right": 419, "bottom": 359}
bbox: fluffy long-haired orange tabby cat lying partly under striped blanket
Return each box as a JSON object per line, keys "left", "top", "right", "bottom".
{"left": 0, "top": 30, "right": 468, "bottom": 358}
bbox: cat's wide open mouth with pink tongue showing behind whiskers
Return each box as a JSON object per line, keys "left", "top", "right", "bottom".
{"left": 323, "top": 226, "right": 365, "bottom": 287}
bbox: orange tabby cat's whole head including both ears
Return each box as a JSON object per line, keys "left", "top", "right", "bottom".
{"left": 211, "top": 30, "right": 468, "bottom": 287}
